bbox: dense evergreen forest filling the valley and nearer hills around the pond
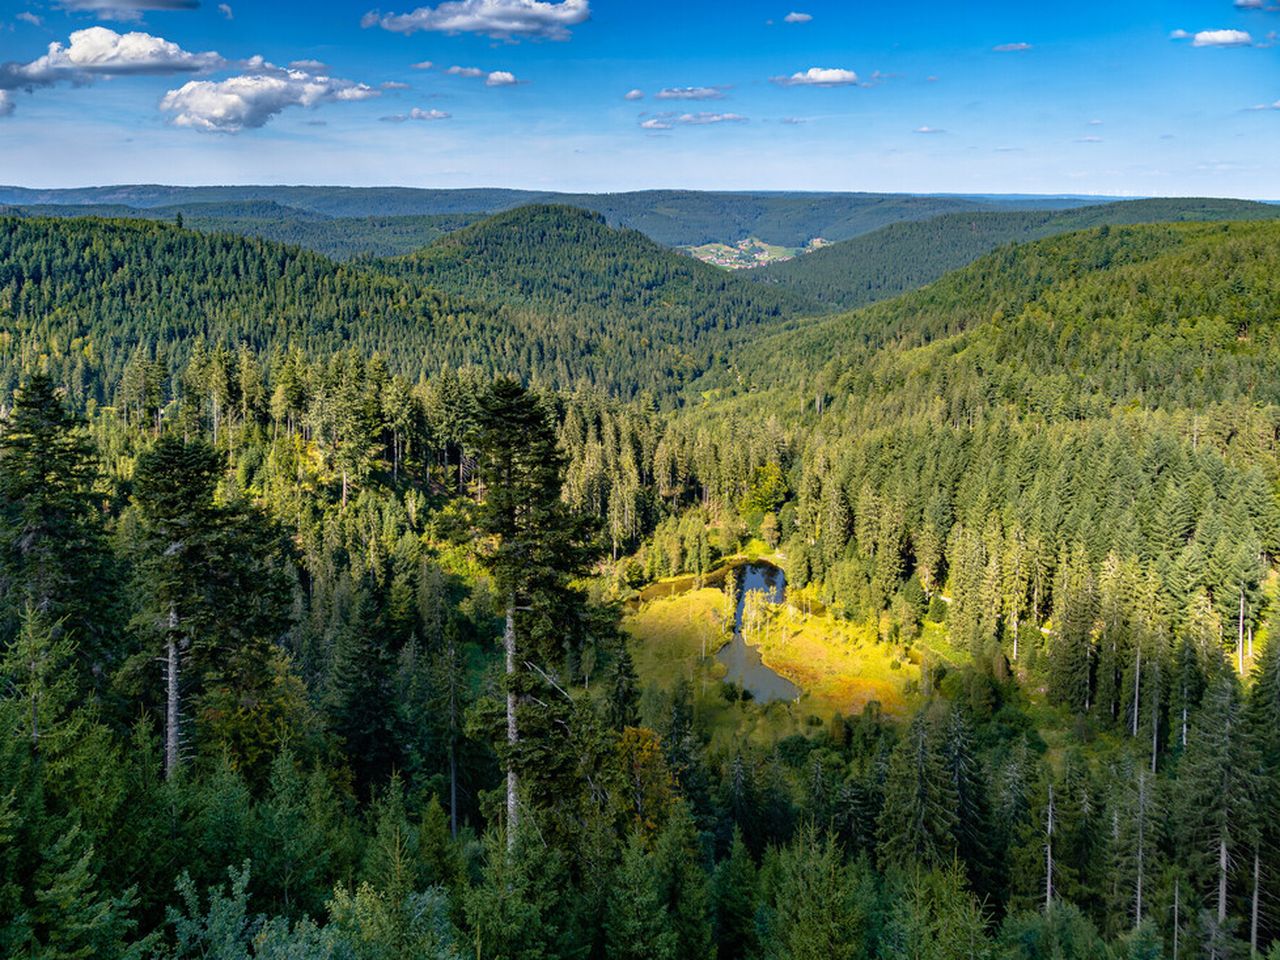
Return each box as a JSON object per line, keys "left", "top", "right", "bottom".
{"left": 0, "top": 205, "right": 1280, "bottom": 960}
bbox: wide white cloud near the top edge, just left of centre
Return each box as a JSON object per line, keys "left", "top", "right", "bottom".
{"left": 361, "top": 0, "right": 591, "bottom": 40}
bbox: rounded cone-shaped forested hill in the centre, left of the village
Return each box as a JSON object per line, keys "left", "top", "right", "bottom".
{"left": 369, "top": 205, "right": 813, "bottom": 393}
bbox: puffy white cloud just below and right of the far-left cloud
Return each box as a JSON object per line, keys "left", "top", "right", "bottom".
{"left": 160, "top": 69, "right": 379, "bottom": 133}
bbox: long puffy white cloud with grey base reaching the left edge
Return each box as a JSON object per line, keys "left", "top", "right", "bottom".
{"left": 0, "top": 27, "right": 227, "bottom": 115}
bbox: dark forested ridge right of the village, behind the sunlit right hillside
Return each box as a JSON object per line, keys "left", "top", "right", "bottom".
{"left": 749, "top": 197, "right": 1280, "bottom": 310}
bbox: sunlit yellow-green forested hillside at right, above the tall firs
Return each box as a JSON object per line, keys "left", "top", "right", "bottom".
{"left": 717, "top": 221, "right": 1280, "bottom": 406}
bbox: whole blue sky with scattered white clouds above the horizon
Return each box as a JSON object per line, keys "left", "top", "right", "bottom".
{"left": 0, "top": 0, "right": 1280, "bottom": 198}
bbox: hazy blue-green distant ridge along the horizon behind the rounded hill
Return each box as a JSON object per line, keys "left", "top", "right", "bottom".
{"left": 0, "top": 184, "right": 1092, "bottom": 252}
